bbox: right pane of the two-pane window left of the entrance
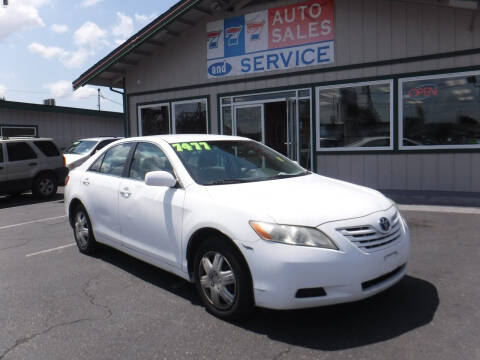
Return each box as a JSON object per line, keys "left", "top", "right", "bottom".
{"left": 173, "top": 100, "right": 207, "bottom": 134}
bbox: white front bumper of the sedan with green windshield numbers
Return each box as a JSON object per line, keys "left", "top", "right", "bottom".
{"left": 245, "top": 211, "right": 410, "bottom": 309}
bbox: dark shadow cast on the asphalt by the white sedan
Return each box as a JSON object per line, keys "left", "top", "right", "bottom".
{"left": 90, "top": 246, "right": 440, "bottom": 351}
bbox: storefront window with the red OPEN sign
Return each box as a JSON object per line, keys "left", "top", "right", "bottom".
{"left": 400, "top": 73, "right": 480, "bottom": 148}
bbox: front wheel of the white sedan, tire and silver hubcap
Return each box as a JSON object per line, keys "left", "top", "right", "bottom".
{"left": 194, "top": 236, "right": 254, "bottom": 320}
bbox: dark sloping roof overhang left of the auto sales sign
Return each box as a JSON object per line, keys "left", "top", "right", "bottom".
{"left": 73, "top": 0, "right": 248, "bottom": 90}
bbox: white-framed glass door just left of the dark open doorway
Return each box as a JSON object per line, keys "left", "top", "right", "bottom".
{"left": 234, "top": 104, "right": 265, "bottom": 143}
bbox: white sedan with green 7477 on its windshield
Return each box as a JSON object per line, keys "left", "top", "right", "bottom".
{"left": 65, "top": 135, "right": 409, "bottom": 319}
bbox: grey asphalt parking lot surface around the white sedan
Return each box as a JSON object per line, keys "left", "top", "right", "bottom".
{"left": 0, "top": 195, "right": 480, "bottom": 360}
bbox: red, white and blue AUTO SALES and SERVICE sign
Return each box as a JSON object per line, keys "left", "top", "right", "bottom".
{"left": 207, "top": 0, "right": 334, "bottom": 78}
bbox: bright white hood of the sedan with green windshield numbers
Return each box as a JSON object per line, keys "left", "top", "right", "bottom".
{"left": 206, "top": 174, "right": 392, "bottom": 227}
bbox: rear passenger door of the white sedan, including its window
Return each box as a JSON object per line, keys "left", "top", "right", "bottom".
{"left": 80, "top": 143, "right": 133, "bottom": 242}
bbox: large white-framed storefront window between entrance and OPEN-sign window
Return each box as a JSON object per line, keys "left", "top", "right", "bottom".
{"left": 317, "top": 81, "right": 393, "bottom": 150}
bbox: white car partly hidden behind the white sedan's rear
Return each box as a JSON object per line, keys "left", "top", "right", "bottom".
{"left": 63, "top": 137, "right": 121, "bottom": 170}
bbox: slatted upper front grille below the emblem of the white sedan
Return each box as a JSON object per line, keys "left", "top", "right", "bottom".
{"left": 337, "top": 212, "right": 402, "bottom": 253}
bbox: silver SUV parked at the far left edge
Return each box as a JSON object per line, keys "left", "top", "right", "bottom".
{"left": 0, "top": 138, "right": 68, "bottom": 198}
